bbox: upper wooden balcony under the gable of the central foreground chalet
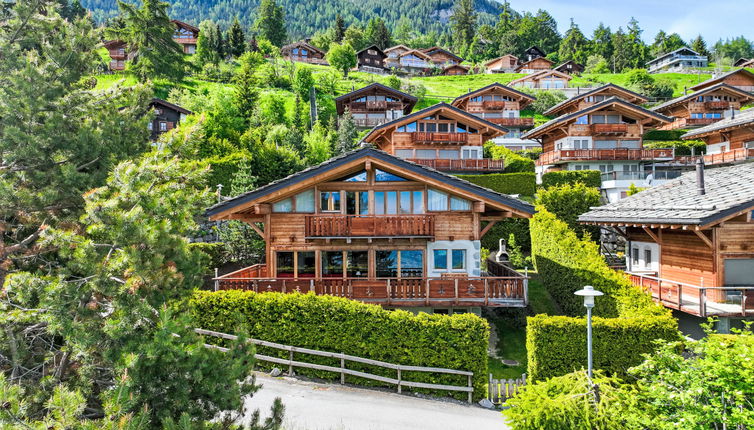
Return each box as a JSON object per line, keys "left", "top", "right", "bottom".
{"left": 306, "top": 214, "right": 435, "bottom": 238}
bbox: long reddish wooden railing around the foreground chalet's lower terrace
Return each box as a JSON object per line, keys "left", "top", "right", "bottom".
{"left": 213, "top": 273, "right": 528, "bottom": 307}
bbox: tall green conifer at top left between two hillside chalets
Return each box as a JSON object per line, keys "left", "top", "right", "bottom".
{"left": 110, "top": 0, "right": 185, "bottom": 81}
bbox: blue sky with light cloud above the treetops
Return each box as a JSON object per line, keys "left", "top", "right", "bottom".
{"left": 506, "top": 0, "right": 754, "bottom": 45}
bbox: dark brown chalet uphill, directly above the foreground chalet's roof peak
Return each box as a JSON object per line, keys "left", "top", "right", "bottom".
{"left": 335, "top": 83, "right": 417, "bottom": 128}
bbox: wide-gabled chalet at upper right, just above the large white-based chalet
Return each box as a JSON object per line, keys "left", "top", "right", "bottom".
{"left": 652, "top": 83, "right": 754, "bottom": 130}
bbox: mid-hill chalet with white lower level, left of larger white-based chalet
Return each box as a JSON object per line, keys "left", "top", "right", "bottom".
{"left": 451, "top": 82, "right": 539, "bottom": 151}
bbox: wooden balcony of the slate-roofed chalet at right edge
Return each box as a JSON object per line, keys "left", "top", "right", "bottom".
{"left": 627, "top": 272, "right": 754, "bottom": 317}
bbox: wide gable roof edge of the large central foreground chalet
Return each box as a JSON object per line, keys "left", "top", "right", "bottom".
{"left": 206, "top": 146, "right": 534, "bottom": 219}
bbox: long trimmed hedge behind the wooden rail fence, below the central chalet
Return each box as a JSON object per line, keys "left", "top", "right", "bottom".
{"left": 191, "top": 291, "right": 489, "bottom": 400}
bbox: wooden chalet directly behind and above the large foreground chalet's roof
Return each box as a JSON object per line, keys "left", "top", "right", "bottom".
{"left": 364, "top": 103, "right": 508, "bottom": 173}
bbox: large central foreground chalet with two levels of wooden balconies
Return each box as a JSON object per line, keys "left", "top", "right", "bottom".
{"left": 207, "top": 147, "right": 534, "bottom": 311}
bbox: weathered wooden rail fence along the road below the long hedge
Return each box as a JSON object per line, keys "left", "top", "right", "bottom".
{"left": 194, "top": 328, "right": 474, "bottom": 403}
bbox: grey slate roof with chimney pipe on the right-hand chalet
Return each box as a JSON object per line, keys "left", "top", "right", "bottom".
{"left": 579, "top": 163, "right": 754, "bottom": 228}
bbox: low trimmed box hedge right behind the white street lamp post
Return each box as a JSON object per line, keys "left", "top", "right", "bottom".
{"left": 526, "top": 314, "right": 681, "bottom": 381}
